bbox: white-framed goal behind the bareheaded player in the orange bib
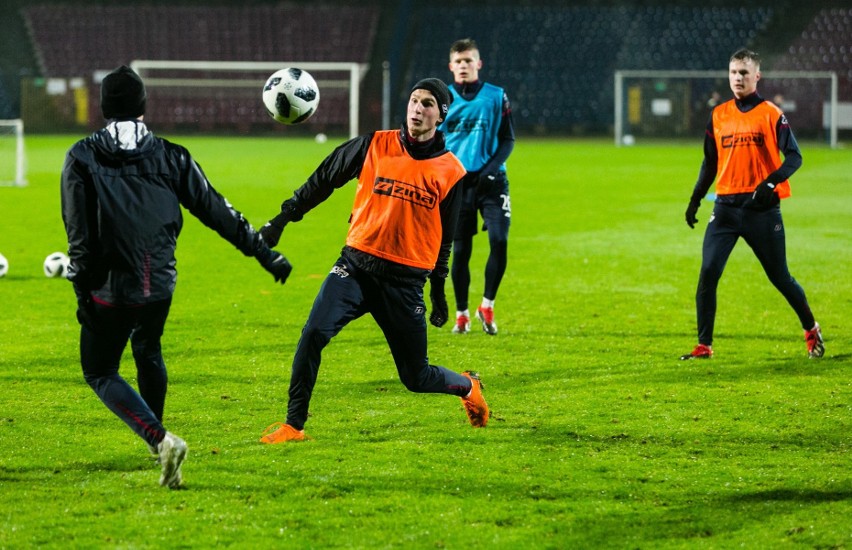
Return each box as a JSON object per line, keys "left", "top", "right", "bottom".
{"left": 614, "top": 71, "right": 838, "bottom": 147}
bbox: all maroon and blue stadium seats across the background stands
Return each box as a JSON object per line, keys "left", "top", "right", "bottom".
{"left": 18, "top": 0, "right": 852, "bottom": 134}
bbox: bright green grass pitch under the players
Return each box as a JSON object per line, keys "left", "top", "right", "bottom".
{"left": 0, "top": 136, "right": 852, "bottom": 548}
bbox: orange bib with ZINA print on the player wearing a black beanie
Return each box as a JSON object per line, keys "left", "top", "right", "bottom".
{"left": 346, "top": 134, "right": 465, "bottom": 269}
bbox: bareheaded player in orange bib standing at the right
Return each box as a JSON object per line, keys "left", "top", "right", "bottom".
{"left": 681, "top": 49, "right": 825, "bottom": 360}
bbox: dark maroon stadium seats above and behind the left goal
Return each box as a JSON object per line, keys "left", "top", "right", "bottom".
{"left": 23, "top": 4, "right": 379, "bottom": 129}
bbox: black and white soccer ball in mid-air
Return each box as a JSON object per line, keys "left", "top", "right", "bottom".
{"left": 263, "top": 67, "right": 319, "bottom": 124}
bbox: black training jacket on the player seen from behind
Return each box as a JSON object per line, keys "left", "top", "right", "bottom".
{"left": 61, "top": 123, "right": 267, "bottom": 305}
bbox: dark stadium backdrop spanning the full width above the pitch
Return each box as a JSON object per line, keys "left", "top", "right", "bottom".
{"left": 0, "top": 0, "right": 852, "bottom": 136}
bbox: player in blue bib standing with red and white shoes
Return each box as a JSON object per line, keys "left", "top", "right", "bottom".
{"left": 439, "top": 38, "right": 515, "bottom": 335}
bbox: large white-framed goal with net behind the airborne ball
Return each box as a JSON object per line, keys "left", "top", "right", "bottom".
{"left": 129, "top": 60, "right": 368, "bottom": 137}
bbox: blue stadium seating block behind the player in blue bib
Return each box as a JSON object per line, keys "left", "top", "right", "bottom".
{"left": 406, "top": 5, "right": 772, "bottom": 133}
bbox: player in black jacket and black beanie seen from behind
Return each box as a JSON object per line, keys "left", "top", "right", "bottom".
{"left": 61, "top": 67, "right": 291, "bottom": 488}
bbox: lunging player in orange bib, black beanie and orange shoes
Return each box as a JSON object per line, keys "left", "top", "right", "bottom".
{"left": 261, "top": 78, "right": 489, "bottom": 444}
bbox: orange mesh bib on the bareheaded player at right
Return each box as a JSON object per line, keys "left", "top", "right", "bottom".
{"left": 713, "top": 99, "right": 790, "bottom": 199}
